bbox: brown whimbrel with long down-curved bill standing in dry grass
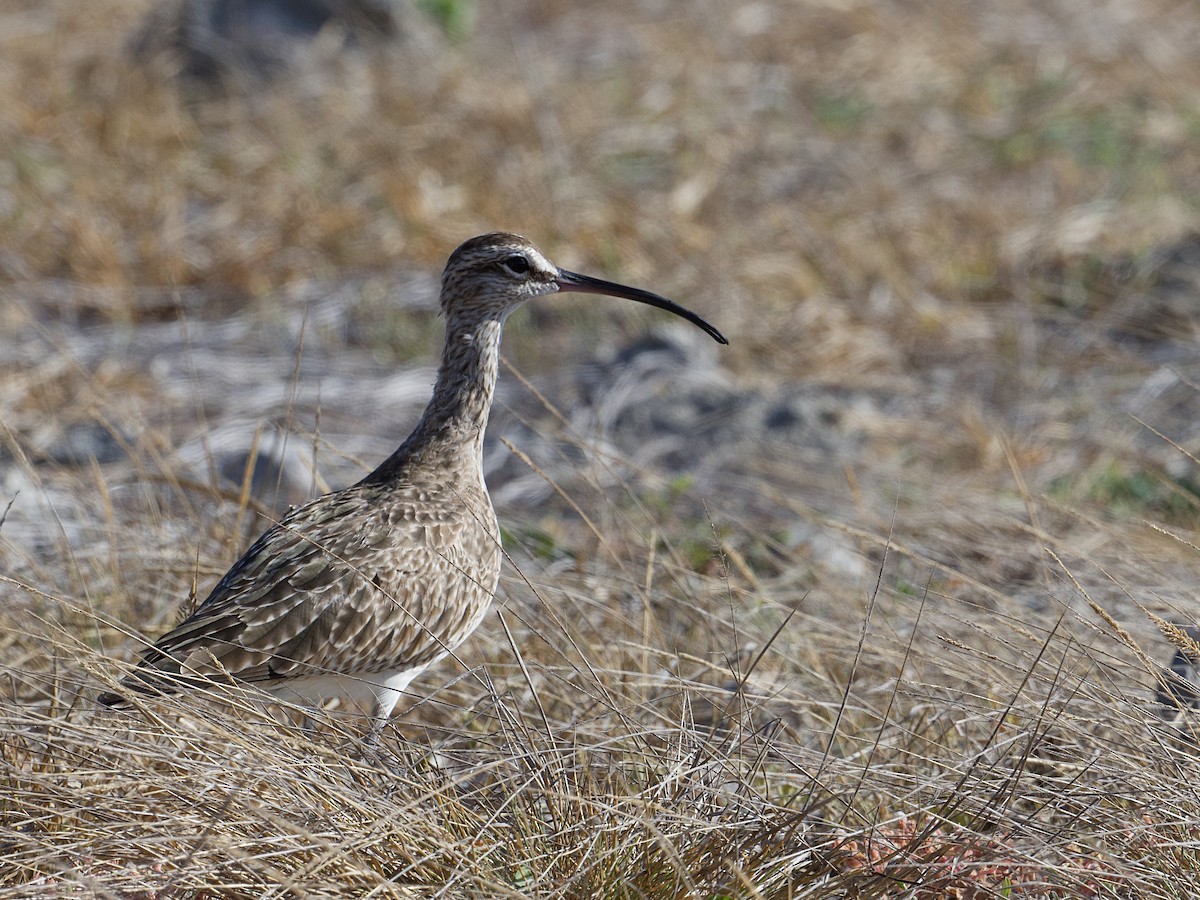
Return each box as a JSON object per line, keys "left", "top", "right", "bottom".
{"left": 100, "top": 233, "right": 727, "bottom": 740}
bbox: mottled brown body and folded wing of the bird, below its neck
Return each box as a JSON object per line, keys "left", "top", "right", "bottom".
{"left": 118, "top": 485, "right": 500, "bottom": 692}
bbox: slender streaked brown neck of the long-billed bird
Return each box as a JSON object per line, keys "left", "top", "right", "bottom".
{"left": 364, "top": 318, "right": 504, "bottom": 482}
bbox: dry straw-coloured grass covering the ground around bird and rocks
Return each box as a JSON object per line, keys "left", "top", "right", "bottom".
{"left": 0, "top": 0, "right": 1200, "bottom": 899}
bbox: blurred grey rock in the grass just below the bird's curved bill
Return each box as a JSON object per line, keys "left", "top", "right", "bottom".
{"left": 485, "top": 323, "right": 883, "bottom": 506}
